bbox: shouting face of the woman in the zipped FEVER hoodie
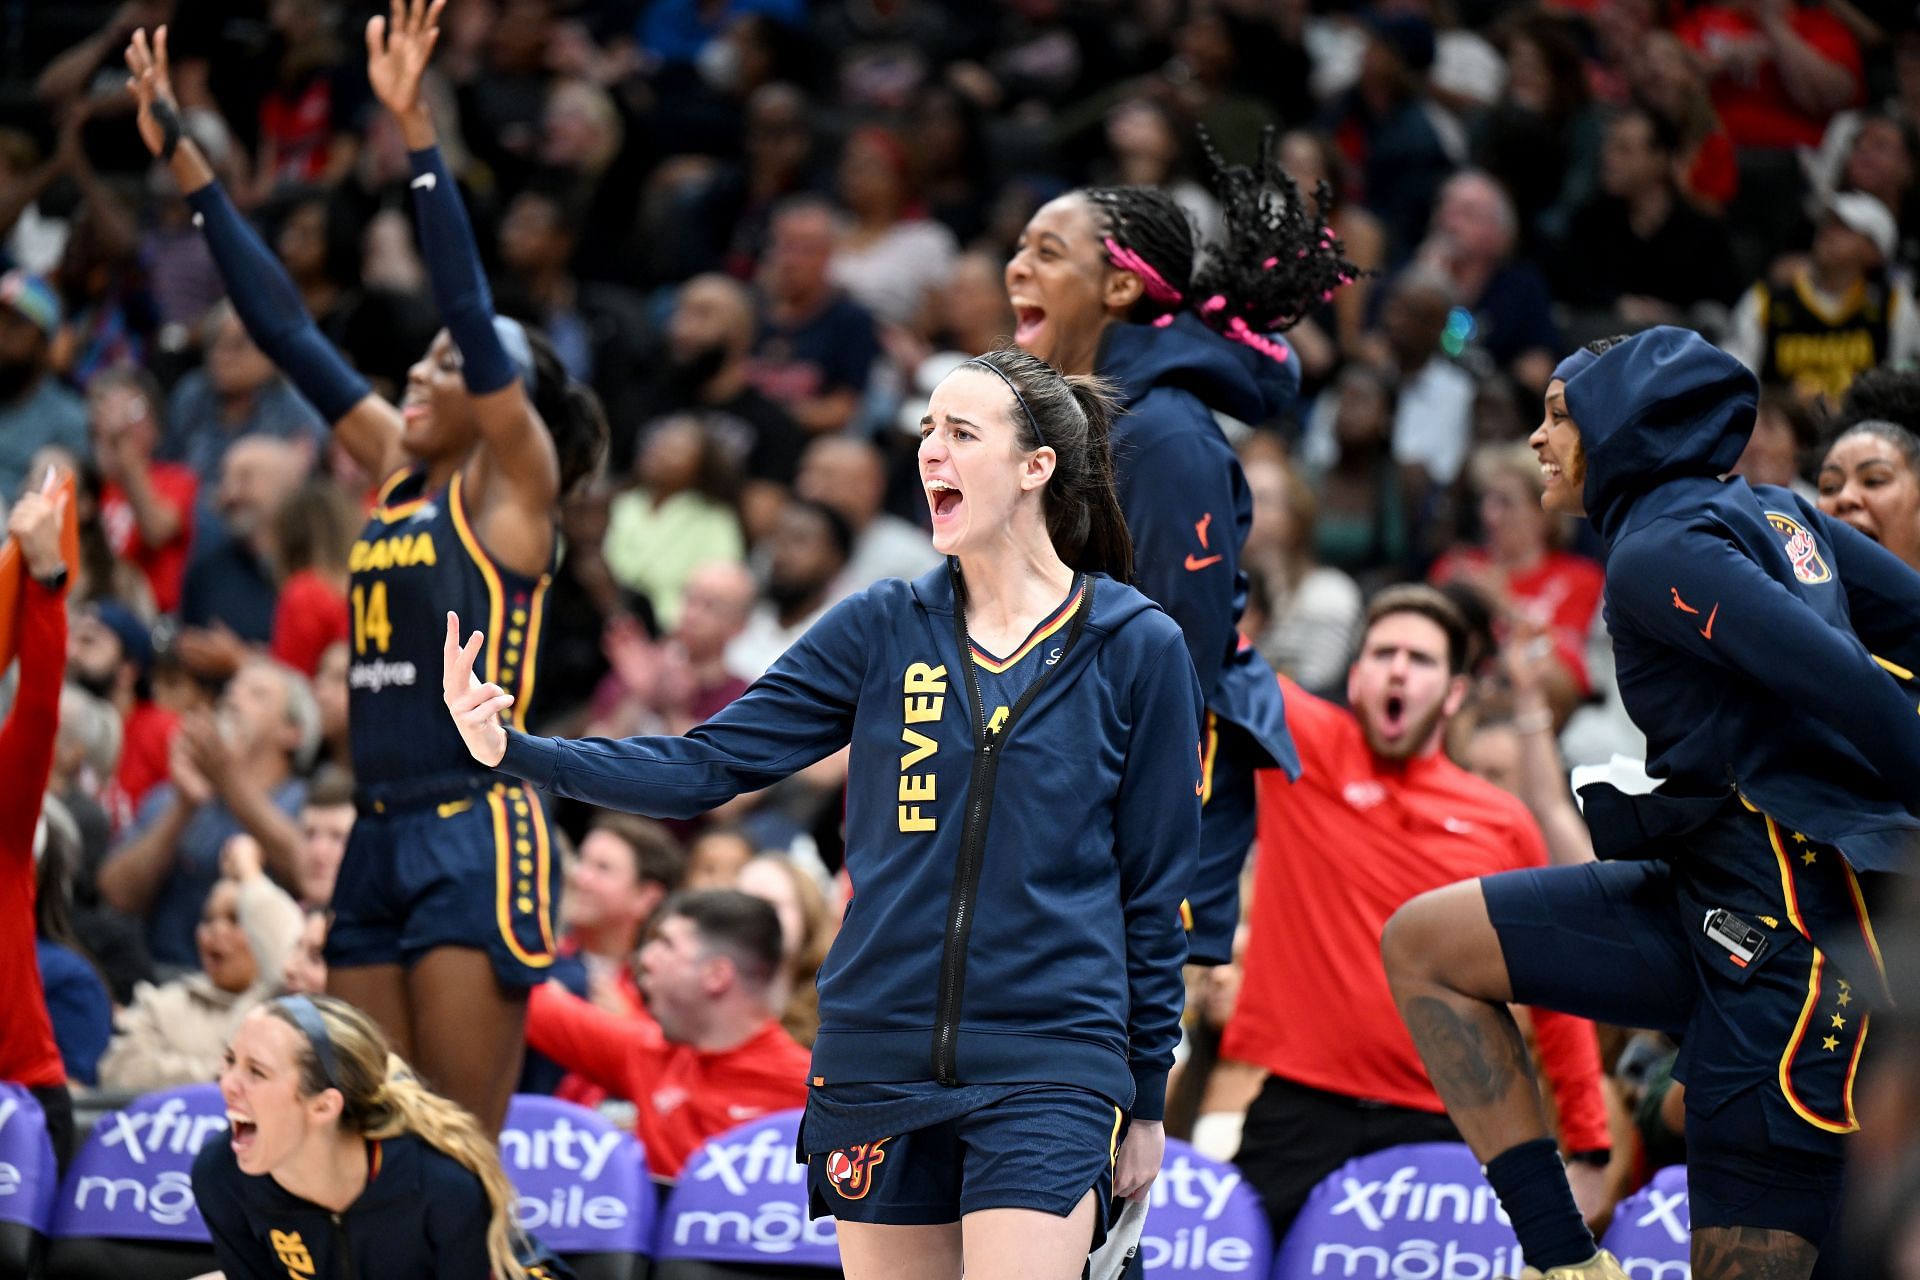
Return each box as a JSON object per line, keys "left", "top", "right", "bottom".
{"left": 920, "top": 365, "right": 1054, "bottom": 557}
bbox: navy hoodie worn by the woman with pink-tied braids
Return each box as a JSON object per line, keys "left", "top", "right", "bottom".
{"left": 1094, "top": 313, "right": 1300, "bottom": 779}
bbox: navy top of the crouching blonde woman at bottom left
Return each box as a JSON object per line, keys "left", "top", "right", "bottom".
{"left": 194, "top": 1136, "right": 572, "bottom": 1280}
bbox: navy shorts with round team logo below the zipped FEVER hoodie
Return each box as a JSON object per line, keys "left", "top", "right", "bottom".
{"left": 806, "top": 1086, "right": 1123, "bottom": 1247}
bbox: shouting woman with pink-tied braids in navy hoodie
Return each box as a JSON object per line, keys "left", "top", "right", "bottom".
{"left": 1006, "top": 130, "right": 1359, "bottom": 963}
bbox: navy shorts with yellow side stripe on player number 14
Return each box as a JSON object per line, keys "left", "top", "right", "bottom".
{"left": 326, "top": 783, "right": 561, "bottom": 990}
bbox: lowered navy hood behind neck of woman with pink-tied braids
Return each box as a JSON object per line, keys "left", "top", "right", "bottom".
{"left": 1094, "top": 311, "right": 1300, "bottom": 424}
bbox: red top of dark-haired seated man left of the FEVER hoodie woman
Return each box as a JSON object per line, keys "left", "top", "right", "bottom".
{"left": 526, "top": 984, "right": 810, "bottom": 1178}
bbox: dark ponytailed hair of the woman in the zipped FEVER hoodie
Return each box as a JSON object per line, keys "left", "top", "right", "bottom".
{"left": 960, "top": 345, "right": 1133, "bottom": 581}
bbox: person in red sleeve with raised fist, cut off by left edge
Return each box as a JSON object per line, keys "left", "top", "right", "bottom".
{"left": 0, "top": 493, "right": 73, "bottom": 1165}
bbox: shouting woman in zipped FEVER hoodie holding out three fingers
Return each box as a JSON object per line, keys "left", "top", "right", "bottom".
{"left": 445, "top": 349, "right": 1202, "bottom": 1280}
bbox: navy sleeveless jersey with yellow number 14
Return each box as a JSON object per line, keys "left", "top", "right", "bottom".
{"left": 348, "top": 470, "right": 549, "bottom": 804}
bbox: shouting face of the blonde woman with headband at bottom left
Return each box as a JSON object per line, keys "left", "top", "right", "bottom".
{"left": 219, "top": 1009, "right": 340, "bottom": 1176}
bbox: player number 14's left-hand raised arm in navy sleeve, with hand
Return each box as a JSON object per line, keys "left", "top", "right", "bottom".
{"left": 127, "top": 27, "right": 407, "bottom": 478}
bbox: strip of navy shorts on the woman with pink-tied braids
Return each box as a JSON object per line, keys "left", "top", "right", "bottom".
{"left": 1187, "top": 712, "right": 1260, "bottom": 965}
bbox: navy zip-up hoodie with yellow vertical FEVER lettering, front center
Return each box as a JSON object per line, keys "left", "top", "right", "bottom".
{"left": 499, "top": 564, "right": 1202, "bottom": 1121}
